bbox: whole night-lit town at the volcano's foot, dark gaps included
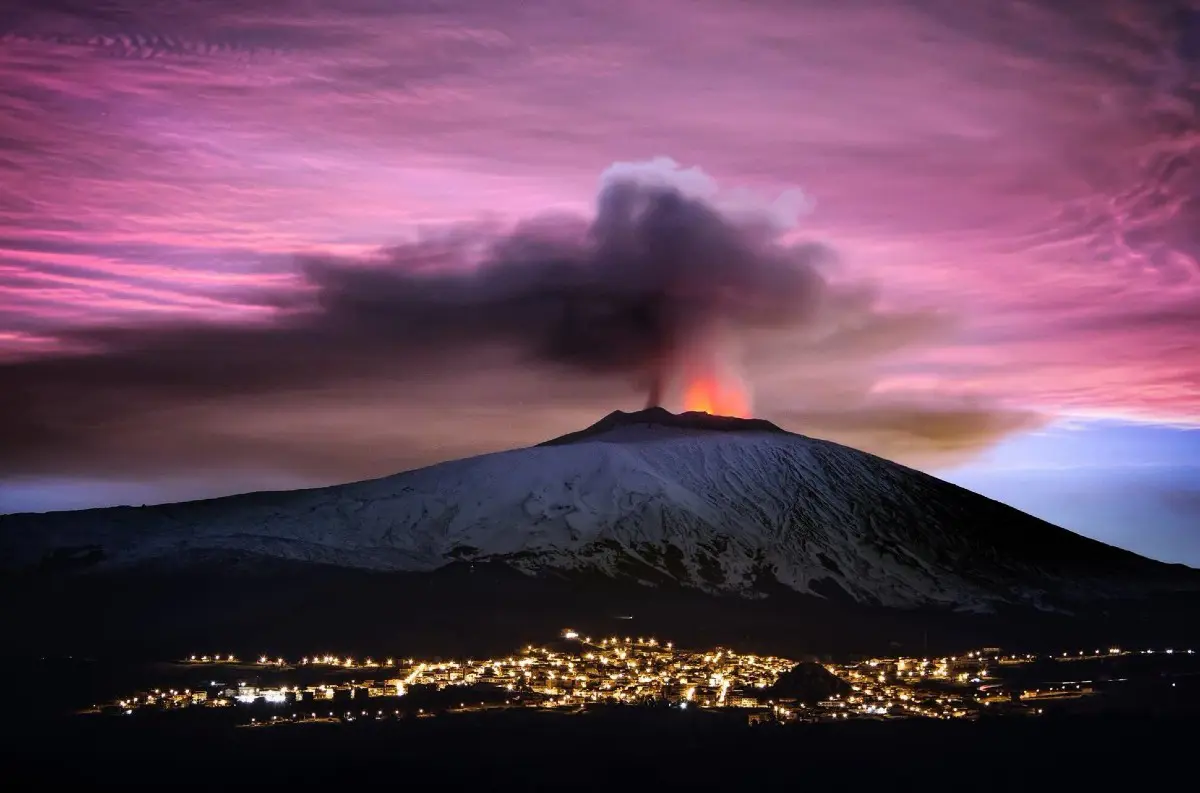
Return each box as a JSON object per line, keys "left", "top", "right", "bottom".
{"left": 80, "top": 629, "right": 1200, "bottom": 727}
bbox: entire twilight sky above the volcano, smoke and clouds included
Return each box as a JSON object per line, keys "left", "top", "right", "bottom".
{"left": 0, "top": 0, "right": 1200, "bottom": 565}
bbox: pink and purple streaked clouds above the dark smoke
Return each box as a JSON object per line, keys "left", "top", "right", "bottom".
{"left": 0, "top": 0, "right": 1200, "bottom": 479}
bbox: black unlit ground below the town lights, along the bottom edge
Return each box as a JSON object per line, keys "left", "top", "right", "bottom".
{"left": 0, "top": 709, "right": 1195, "bottom": 791}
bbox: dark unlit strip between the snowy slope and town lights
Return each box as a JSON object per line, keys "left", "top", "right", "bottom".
{"left": 0, "top": 563, "right": 1200, "bottom": 661}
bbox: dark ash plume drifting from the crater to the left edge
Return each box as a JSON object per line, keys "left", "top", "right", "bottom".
{"left": 0, "top": 171, "right": 830, "bottom": 474}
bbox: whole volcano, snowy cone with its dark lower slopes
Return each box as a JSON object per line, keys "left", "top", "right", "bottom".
{"left": 0, "top": 408, "right": 1200, "bottom": 657}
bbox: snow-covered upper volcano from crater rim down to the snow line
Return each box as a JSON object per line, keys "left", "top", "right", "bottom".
{"left": 0, "top": 408, "right": 1194, "bottom": 609}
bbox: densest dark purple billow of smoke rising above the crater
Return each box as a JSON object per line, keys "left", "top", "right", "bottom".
{"left": 276, "top": 172, "right": 828, "bottom": 404}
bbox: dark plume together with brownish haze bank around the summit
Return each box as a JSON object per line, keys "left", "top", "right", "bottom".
{"left": 0, "top": 160, "right": 1032, "bottom": 479}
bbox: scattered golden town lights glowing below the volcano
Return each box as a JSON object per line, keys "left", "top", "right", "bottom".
{"left": 100, "top": 629, "right": 1194, "bottom": 723}
